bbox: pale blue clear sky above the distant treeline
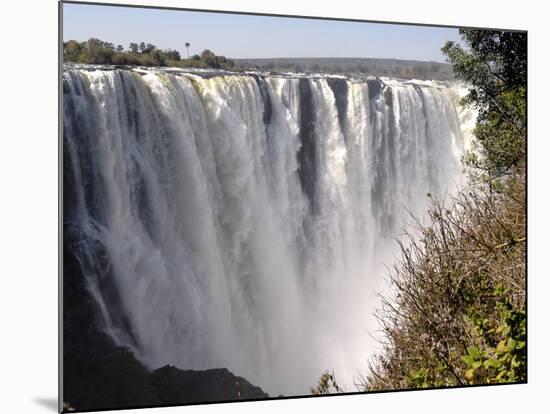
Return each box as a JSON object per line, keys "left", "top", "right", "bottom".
{"left": 63, "top": 4, "right": 459, "bottom": 62}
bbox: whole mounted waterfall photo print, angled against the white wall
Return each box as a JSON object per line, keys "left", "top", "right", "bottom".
{"left": 60, "top": 1, "right": 527, "bottom": 412}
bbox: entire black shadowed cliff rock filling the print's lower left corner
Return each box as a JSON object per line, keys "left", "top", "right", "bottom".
{"left": 63, "top": 228, "right": 269, "bottom": 411}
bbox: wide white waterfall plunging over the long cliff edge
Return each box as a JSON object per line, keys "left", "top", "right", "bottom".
{"left": 63, "top": 66, "right": 474, "bottom": 395}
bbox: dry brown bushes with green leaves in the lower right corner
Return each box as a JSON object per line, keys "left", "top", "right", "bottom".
{"left": 364, "top": 174, "right": 527, "bottom": 391}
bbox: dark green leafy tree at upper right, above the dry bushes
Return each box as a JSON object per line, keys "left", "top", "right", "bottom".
{"left": 442, "top": 29, "right": 527, "bottom": 181}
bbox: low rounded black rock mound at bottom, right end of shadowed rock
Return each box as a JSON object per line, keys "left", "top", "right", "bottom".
{"left": 152, "top": 366, "right": 269, "bottom": 404}
